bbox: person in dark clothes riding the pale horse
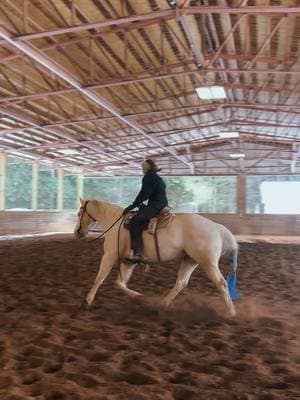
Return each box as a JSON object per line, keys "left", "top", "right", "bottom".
{"left": 123, "top": 159, "right": 168, "bottom": 261}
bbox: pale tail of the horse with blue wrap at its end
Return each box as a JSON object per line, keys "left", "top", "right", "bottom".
{"left": 219, "top": 225, "right": 241, "bottom": 300}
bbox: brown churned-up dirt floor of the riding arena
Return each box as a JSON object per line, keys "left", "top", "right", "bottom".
{"left": 0, "top": 235, "right": 300, "bottom": 400}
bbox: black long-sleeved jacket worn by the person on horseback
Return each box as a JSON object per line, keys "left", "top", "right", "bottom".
{"left": 132, "top": 170, "right": 168, "bottom": 211}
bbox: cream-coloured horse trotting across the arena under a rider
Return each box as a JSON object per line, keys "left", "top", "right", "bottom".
{"left": 74, "top": 199, "right": 238, "bottom": 316}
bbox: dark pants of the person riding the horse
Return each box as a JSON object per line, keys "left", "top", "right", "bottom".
{"left": 129, "top": 206, "right": 160, "bottom": 254}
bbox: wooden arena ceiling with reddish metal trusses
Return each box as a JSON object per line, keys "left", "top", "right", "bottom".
{"left": 0, "top": 0, "right": 300, "bottom": 175}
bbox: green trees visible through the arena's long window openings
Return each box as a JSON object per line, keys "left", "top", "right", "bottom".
{"left": 6, "top": 156, "right": 300, "bottom": 214}
